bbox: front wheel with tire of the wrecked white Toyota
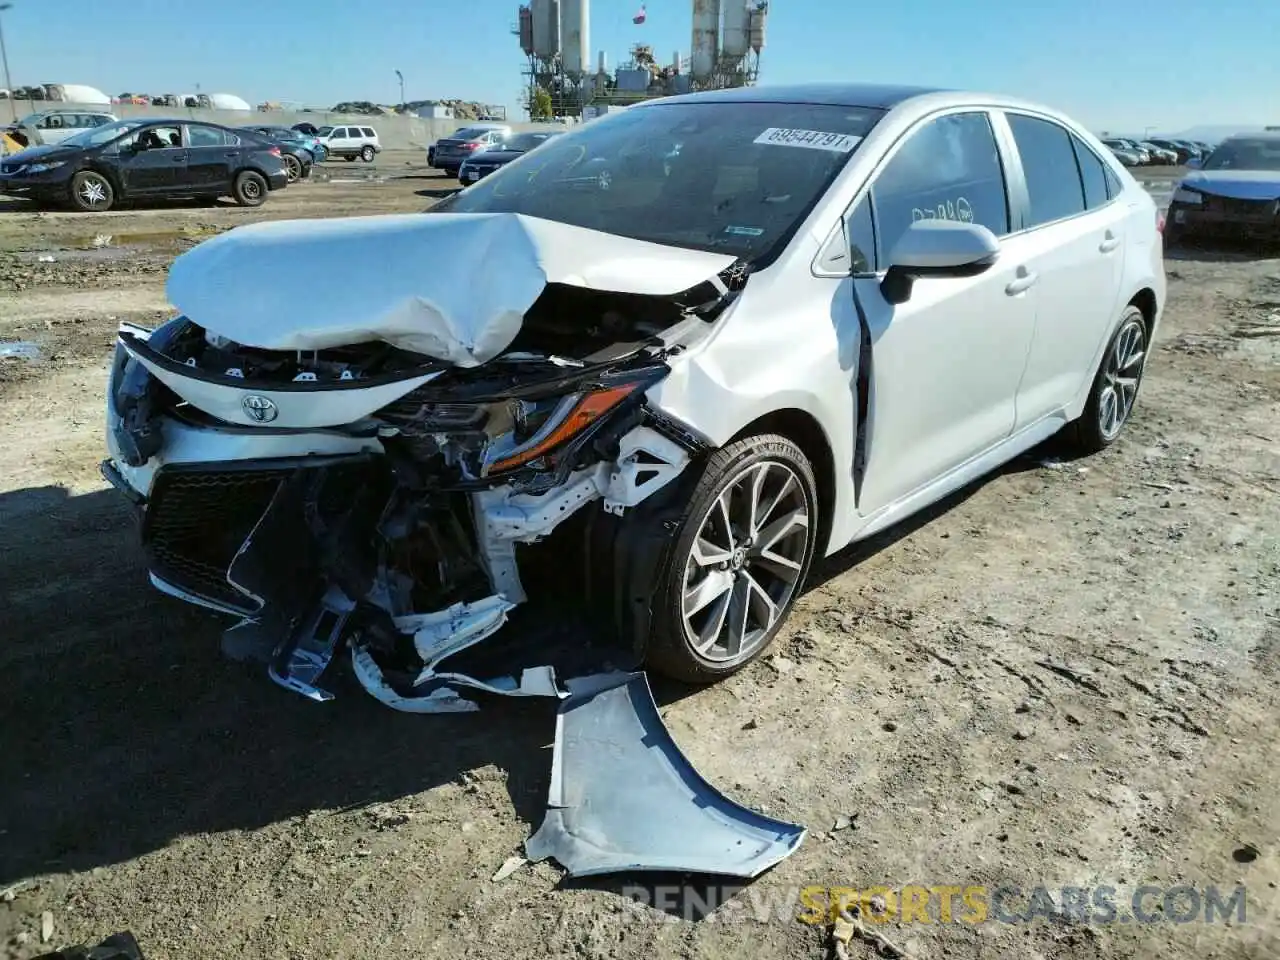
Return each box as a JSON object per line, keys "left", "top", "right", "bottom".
{"left": 645, "top": 434, "right": 818, "bottom": 684}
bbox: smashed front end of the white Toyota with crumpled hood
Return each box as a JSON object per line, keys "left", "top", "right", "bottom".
{"left": 104, "top": 215, "right": 745, "bottom": 713}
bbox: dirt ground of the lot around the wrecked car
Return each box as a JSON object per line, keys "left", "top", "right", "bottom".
{"left": 0, "top": 155, "right": 1280, "bottom": 960}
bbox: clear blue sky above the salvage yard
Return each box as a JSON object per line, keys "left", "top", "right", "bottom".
{"left": 3, "top": 0, "right": 1280, "bottom": 132}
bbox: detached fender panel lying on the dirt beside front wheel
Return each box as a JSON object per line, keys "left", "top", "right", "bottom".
{"left": 525, "top": 673, "right": 805, "bottom": 878}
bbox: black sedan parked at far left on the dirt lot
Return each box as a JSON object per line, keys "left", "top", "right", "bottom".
{"left": 0, "top": 119, "right": 289, "bottom": 212}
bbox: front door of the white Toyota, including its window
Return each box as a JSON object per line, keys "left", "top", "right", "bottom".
{"left": 846, "top": 110, "right": 1036, "bottom": 516}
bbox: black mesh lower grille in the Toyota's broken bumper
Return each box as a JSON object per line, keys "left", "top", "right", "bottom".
{"left": 143, "top": 470, "right": 292, "bottom": 608}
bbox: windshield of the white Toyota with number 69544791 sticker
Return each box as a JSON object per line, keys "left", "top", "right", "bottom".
{"left": 434, "top": 101, "right": 884, "bottom": 265}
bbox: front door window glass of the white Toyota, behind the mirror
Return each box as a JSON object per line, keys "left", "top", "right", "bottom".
{"left": 872, "top": 111, "right": 1009, "bottom": 261}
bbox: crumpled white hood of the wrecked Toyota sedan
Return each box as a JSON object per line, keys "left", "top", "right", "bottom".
{"left": 166, "top": 214, "right": 735, "bottom": 366}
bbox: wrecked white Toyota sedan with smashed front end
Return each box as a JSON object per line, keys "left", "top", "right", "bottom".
{"left": 104, "top": 86, "right": 1165, "bottom": 712}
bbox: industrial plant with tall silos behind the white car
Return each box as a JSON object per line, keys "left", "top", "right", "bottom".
{"left": 516, "top": 0, "right": 768, "bottom": 118}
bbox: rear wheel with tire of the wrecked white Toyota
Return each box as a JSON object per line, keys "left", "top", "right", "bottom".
{"left": 1064, "top": 303, "right": 1149, "bottom": 456}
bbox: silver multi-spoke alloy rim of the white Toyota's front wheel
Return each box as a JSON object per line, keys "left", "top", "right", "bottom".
{"left": 681, "top": 461, "right": 810, "bottom": 664}
